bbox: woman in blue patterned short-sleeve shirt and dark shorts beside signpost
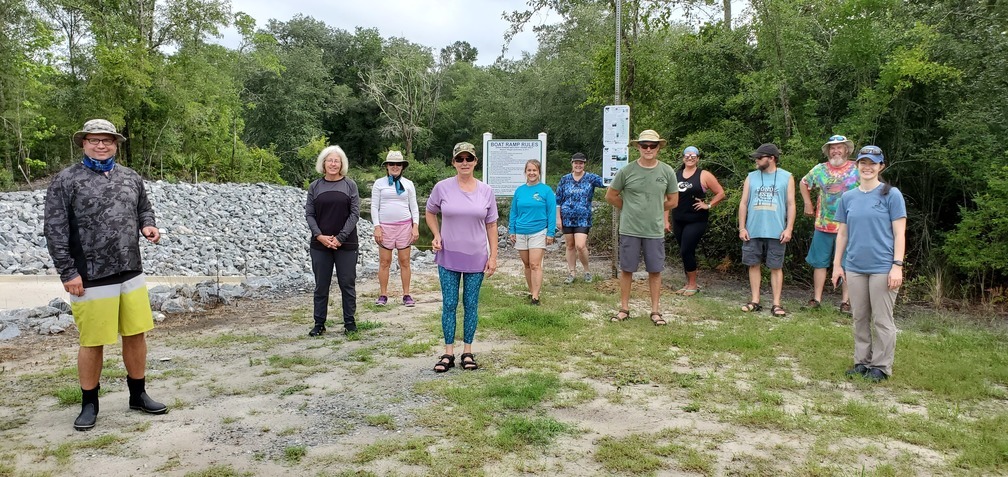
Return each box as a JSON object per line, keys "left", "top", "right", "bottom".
{"left": 556, "top": 152, "right": 604, "bottom": 283}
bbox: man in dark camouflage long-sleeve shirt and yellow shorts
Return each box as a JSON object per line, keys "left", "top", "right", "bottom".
{"left": 44, "top": 119, "right": 167, "bottom": 431}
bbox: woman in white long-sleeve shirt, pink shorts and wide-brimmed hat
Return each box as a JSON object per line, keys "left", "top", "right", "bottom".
{"left": 371, "top": 150, "right": 420, "bottom": 307}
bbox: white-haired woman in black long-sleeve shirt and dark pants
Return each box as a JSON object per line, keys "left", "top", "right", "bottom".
{"left": 304, "top": 146, "right": 361, "bottom": 336}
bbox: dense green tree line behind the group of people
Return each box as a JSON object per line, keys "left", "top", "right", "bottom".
{"left": 0, "top": 0, "right": 1008, "bottom": 302}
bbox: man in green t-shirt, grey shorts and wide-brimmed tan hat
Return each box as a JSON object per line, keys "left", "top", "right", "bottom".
{"left": 606, "top": 129, "right": 679, "bottom": 326}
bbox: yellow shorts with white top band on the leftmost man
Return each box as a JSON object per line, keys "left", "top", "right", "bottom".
{"left": 70, "top": 273, "right": 154, "bottom": 346}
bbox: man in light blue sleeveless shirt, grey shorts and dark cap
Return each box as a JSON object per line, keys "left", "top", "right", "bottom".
{"left": 739, "top": 143, "right": 795, "bottom": 317}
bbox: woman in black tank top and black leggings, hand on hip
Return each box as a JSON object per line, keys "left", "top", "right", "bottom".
{"left": 672, "top": 146, "right": 725, "bottom": 296}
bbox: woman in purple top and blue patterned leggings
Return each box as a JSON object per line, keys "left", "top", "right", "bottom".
{"left": 425, "top": 142, "right": 497, "bottom": 373}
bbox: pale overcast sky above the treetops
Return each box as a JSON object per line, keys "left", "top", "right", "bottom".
{"left": 219, "top": 0, "right": 559, "bottom": 65}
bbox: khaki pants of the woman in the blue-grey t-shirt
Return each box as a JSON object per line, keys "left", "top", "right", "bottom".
{"left": 847, "top": 271, "right": 899, "bottom": 376}
